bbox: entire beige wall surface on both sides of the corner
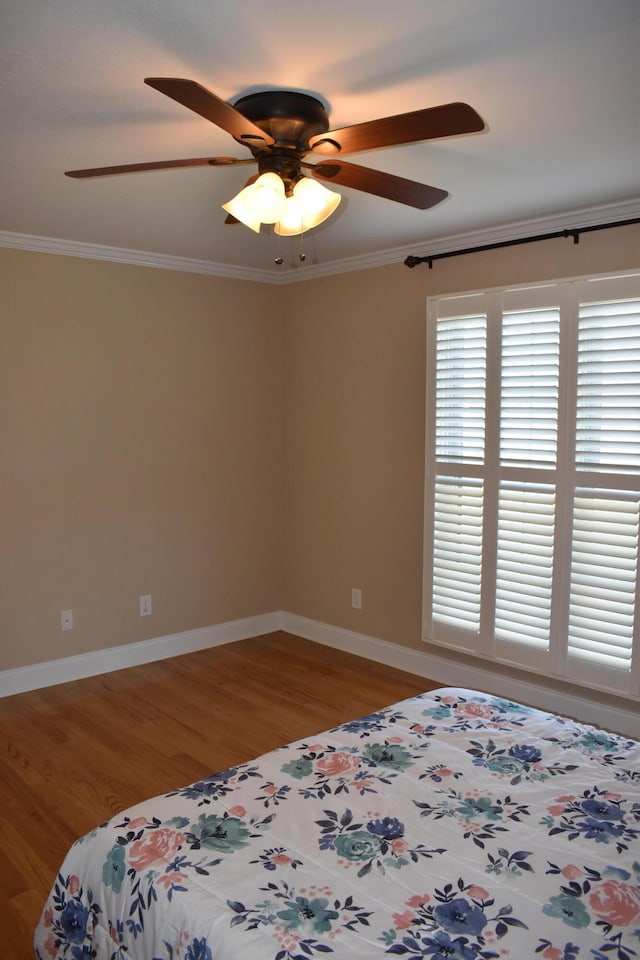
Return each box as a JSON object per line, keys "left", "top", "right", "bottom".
{"left": 0, "top": 227, "right": 640, "bottom": 670}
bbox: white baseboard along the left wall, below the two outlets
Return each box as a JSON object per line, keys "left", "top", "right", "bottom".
{"left": 0, "top": 611, "right": 282, "bottom": 697}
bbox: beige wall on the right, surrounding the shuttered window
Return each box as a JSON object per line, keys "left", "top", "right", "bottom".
{"left": 284, "top": 226, "right": 640, "bottom": 648}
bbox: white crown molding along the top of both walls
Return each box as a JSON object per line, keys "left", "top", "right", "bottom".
{"left": 0, "top": 199, "right": 640, "bottom": 286}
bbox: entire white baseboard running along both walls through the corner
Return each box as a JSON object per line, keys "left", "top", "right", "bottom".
{"left": 0, "top": 610, "right": 640, "bottom": 739}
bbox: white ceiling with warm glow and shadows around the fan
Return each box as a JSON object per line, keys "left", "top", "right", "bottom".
{"left": 0, "top": 0, "right": 640, "bottom": 276}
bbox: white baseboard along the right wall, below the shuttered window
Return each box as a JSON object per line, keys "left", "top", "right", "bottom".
{"left": 282, "top": 612, "right": 640, "bottom": 739}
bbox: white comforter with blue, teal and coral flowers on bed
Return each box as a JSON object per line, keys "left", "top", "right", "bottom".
{"left": 34, "top": 688, "right": 640, "bottom": 960}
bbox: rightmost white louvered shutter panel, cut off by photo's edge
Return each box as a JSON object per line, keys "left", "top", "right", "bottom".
{"left": 568, "top": 284, "right": 640, "bottom": 686}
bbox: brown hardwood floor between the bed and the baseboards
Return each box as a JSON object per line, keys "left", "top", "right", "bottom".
{"left": 0, "top": 633, "right": 437, "bottom": 960}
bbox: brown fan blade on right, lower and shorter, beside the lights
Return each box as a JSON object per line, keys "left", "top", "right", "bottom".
{"left": 304, "top": 158, "right": 449, "bottom": 210}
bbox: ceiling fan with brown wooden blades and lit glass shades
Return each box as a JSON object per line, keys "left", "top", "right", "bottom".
{"left": 66, "top": 77, "right": 484, "bottom": 236}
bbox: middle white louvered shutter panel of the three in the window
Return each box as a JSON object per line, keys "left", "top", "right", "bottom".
{"left": 495, "top": 307, "right": 560, "bottom": 661}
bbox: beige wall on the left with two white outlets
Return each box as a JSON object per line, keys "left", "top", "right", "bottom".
{"left": 0, "top": 250, "right": 283, "bottom": 669}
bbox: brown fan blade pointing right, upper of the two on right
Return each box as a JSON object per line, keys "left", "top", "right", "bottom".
{"left": 310, "top": 103, "right": 484, "bottom": 154}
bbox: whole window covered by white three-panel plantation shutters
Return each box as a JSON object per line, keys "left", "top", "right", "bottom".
{"left": 423, "top": 274, "right": 640, "bottom": 697}
